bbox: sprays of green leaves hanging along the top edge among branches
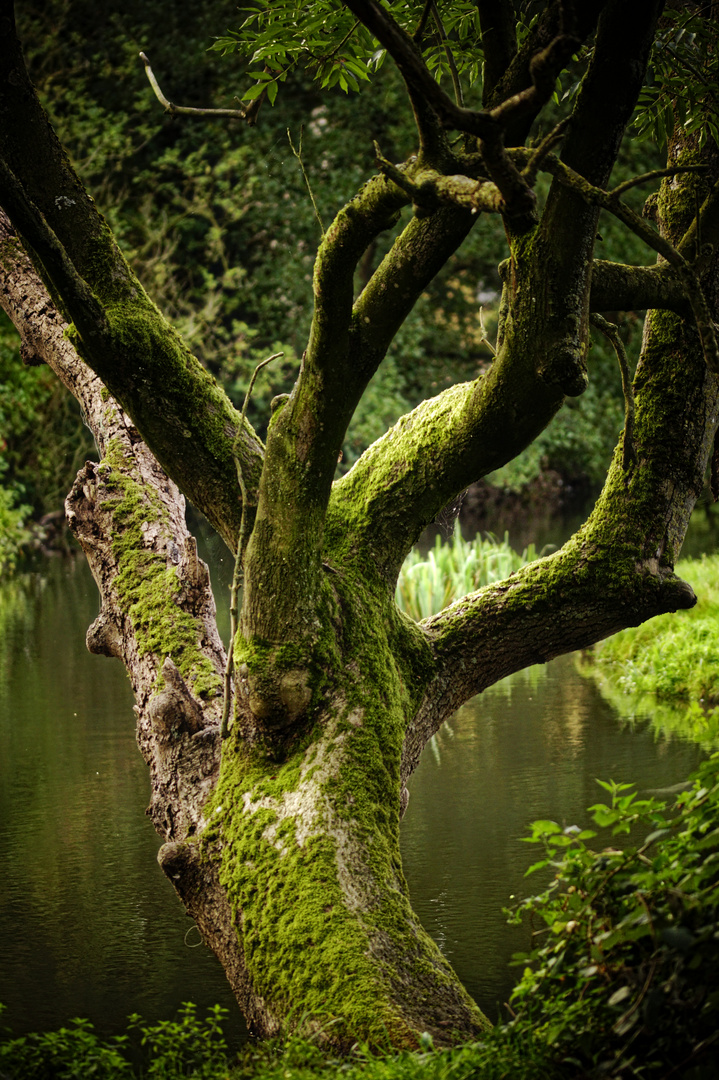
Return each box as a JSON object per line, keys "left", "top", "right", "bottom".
{"left": 213, "top": 0, "right": 719, "bottom": 146}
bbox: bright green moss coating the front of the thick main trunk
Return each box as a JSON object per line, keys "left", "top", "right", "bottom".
{"left": 203, "top": 573, "right": 480, "bottom": 1044}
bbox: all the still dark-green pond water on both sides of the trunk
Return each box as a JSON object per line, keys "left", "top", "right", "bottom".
{"left": 0, "top": 559, "right": 701, "bottom": 1040}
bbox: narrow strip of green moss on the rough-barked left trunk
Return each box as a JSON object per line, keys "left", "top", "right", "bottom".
{"left": 98, "top": 443, "right": 221, "bottom": 698}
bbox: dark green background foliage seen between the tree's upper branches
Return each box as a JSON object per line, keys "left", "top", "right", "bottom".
{"left": 4, "top": 0, "right": 656, "bottom": 514}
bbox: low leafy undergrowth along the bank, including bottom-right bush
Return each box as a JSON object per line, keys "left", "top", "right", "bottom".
{"left": 5, "top": 754, "right": 719, "bottom": 1080}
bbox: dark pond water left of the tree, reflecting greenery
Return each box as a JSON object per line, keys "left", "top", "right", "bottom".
{"left": 0, "top": 561, "right": 239, "bottom": 1034}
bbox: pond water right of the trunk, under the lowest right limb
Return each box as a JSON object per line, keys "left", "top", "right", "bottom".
{"left": 402, "top": 657, "right": 702, "bottom": 1020}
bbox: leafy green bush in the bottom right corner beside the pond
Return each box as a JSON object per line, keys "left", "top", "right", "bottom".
{"left": 500, "top": 755, "right": 719, "bottom": 1077}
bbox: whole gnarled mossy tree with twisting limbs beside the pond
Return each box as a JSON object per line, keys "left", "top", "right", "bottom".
{"left": 0, "top": 0, "right": 719, "bottom": 1047}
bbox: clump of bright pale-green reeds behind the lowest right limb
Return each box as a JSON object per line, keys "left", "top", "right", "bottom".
{"left": 396, "top": 528, "right": 546, "bottom": 620}
